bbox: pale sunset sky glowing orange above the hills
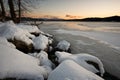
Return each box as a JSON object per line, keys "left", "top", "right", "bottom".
{"left": 29, "top": 0, "right": 120, "bottom": 19}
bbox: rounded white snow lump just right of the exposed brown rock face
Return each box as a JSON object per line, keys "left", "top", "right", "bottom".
{"left": 33, "top": 34, "right": 48, "bottom": 50}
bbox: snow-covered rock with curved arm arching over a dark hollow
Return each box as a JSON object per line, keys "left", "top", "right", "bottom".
{"left": 55, "top": 51, "right": 105, "bottom": 76}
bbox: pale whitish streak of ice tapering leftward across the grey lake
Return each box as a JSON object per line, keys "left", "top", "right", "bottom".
{"left": 56, "top": 29, "right": 120, "bottom": 50}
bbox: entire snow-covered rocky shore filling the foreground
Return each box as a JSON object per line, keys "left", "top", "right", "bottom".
{"left": 0, "top": 21, "right": 104, "bottom": 80}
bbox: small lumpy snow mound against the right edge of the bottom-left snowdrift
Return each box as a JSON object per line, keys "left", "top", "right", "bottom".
{"left": 30, "top": 51, "right": 53, "bottom": 69}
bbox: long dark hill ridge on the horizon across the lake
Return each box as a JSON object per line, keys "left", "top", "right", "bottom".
{"left": 22, "top": 16, "right": 120, "bottom": 22}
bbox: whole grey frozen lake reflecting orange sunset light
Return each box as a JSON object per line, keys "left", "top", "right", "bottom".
{"left": 39, "top": 22, "right": 120, "bottom": 78}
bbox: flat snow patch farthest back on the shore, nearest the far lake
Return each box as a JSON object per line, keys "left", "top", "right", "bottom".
{"left": 17, "top": 24, "right": 40, "bottom": 33}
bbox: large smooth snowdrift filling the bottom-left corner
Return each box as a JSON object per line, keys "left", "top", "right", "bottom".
{"left": 0, "top": 44, "right": 50, "bottom": 80}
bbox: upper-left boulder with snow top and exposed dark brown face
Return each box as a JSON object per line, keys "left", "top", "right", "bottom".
{"left": 0, "top": 21, "right": 35, "bottom": 52}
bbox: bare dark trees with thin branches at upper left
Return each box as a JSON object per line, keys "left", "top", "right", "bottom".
{"left": 0, "top": 0, "right": 39, "bottom": 23}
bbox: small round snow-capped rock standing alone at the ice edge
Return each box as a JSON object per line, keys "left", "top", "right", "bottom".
{"left": 56, "top": 40, "right": 70, "bottom": 51}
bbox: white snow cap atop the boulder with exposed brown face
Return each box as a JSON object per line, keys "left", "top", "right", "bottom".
{"left": 0, "top": 21, "right": 34, "bottom": 45}
